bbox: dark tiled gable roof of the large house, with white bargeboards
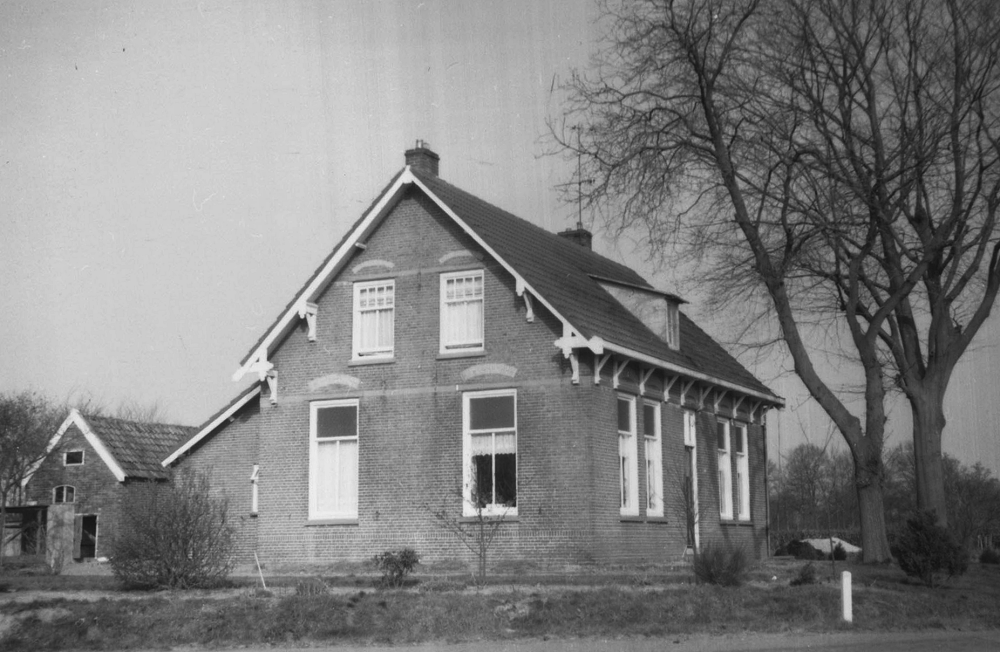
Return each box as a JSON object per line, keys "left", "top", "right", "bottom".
{"left": 233, "top": 159, "right": 784, "bottom": 405}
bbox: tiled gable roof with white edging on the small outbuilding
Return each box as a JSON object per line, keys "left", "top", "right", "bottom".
{"left": 22, "top": 408, "right": 195, "bottom": 485}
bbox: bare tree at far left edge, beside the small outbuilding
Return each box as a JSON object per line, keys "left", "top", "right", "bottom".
{"left": 0, "top": 391, "right": 65, "bottom": 565}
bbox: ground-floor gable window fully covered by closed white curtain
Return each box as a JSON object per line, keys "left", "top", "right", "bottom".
{"left": 309, "top": 399, "right": 358, "bottom": 520}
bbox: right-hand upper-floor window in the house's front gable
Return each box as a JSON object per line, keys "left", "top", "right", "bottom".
{"left": 441, "top": 271, "right": 483, "bottom": 353}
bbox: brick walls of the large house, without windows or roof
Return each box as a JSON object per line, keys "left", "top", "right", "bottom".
{"left": 182, "top": 186, "right": 763, "bottom": 563}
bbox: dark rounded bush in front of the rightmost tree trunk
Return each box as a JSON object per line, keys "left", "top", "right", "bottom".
{"left": 893, "top": 512, "right": 969, "bottom": 586}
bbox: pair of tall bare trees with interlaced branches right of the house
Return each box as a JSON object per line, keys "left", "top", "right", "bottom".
{"left": 552, "top": 0, "right": 1000, "bottom": 561}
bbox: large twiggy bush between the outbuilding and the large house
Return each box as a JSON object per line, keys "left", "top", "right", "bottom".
{"left": 111, "top": 473, "right": 234, "bottom": 589}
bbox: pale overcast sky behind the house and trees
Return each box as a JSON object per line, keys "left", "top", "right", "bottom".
{"left": 0, "top": 0, "right": 1000, "bottom": 472}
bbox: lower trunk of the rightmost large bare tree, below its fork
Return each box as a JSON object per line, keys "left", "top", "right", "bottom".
{"left": 909, "top": 379, "right": 948, "bottom": 526}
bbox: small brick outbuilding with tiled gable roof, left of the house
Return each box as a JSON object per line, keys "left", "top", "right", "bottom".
{"left": 23, "top": 409, "right": 196, "bottom": 561}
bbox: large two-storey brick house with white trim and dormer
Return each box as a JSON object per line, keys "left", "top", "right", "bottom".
{"left": 164, "top": 141, "right": 783, "bottom": 562}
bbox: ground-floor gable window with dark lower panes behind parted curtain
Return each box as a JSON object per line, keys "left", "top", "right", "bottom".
{"left": 462, "top": 390, "right": 517, "bottom": 516}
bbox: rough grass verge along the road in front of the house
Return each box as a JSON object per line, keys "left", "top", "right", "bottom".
{"left": 0, "top": 561, "right": 1000, "bottom": 652}
